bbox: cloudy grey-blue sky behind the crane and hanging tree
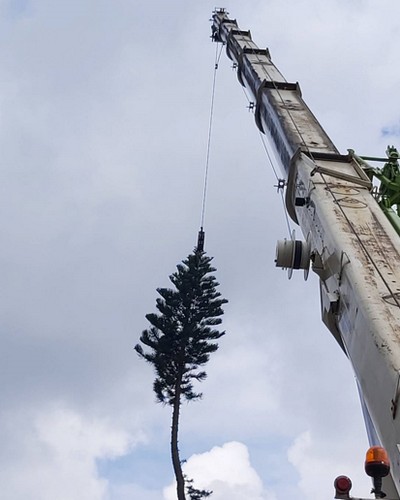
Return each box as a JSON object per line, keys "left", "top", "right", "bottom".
{"left": 0, "top": 0, "right": 400, "bottom": 500}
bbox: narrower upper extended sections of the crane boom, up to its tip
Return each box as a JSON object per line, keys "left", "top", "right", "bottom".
{"left": 212, "top": 10, "right": 338, "bottom": 175}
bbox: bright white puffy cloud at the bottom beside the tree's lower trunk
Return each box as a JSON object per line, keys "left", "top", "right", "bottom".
{"left": 164, "top": 442, "right": 275, "bottom": 500}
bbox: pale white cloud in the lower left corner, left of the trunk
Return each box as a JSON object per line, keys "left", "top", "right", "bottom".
{"left": 0, "top": 405, "right": 142, "bottom": 500}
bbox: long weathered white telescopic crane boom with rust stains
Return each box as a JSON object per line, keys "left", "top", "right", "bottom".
{"left": 212, "top": 9, "right": 400, "bottom": 499}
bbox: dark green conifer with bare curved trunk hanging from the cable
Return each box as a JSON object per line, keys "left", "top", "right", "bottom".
{"left": 135, "top": 247, "right": 228, "bottom": 500}
